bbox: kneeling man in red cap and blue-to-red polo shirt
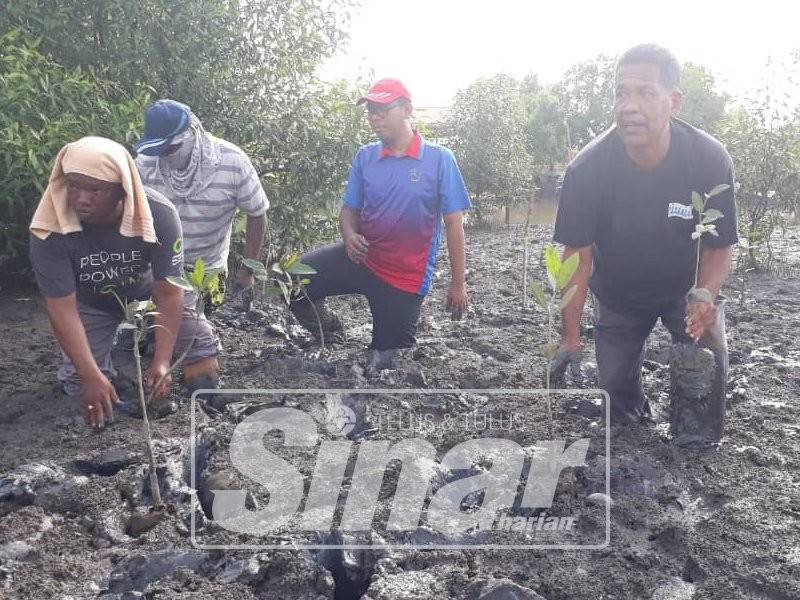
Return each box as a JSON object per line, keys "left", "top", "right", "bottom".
{"left": 292, "top": 79, "right": 471, "bottom": 351}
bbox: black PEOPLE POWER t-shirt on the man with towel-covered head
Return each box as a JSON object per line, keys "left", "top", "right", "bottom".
{"left": 30, "top": 188, "right": 183, "bottom": 313}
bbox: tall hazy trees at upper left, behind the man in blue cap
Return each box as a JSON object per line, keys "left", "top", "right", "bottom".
{"left": 0, "top": 0, "right": 368, "bottom": 254}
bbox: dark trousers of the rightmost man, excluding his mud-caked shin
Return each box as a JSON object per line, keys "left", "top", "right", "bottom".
{"left": 594, "top": 297, "right": 728, "bottom": 419}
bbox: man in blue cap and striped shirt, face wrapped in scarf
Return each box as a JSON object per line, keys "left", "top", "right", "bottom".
{"left": 134, "top": 100, "right": 269, "bottom": 304}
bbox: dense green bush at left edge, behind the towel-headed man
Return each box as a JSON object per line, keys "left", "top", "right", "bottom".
{"left": 0, "top": 29, "right": 149, "bottom": 277}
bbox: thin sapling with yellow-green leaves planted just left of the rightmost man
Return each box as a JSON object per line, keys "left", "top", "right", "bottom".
{"left": 531, "top": 244, "right": 580, "bottom": 434}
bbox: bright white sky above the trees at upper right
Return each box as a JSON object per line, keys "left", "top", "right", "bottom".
{"left": 321, "top": 0, "right": 800, "bottom": 107}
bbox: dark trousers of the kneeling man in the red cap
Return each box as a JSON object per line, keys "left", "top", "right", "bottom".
{"left": 291, "top": 242, "right": 423, "bottom": 350}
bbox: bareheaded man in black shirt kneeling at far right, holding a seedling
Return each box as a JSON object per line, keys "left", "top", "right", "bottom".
{"left": 551, "top": 44, "right": 737, "bottom": 435}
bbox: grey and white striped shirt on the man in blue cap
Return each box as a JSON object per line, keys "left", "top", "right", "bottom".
{"left": 136, "top": 134, "right": 269, "bottom": 269}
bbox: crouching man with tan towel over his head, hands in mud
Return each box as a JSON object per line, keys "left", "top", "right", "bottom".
{"left": 30, "top": 137, "right": 219, "bottom": 426}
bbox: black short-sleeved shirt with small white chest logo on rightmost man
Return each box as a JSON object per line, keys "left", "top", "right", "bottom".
{"left": 553, "top": 119, "right": 737, "bottom": 314}
